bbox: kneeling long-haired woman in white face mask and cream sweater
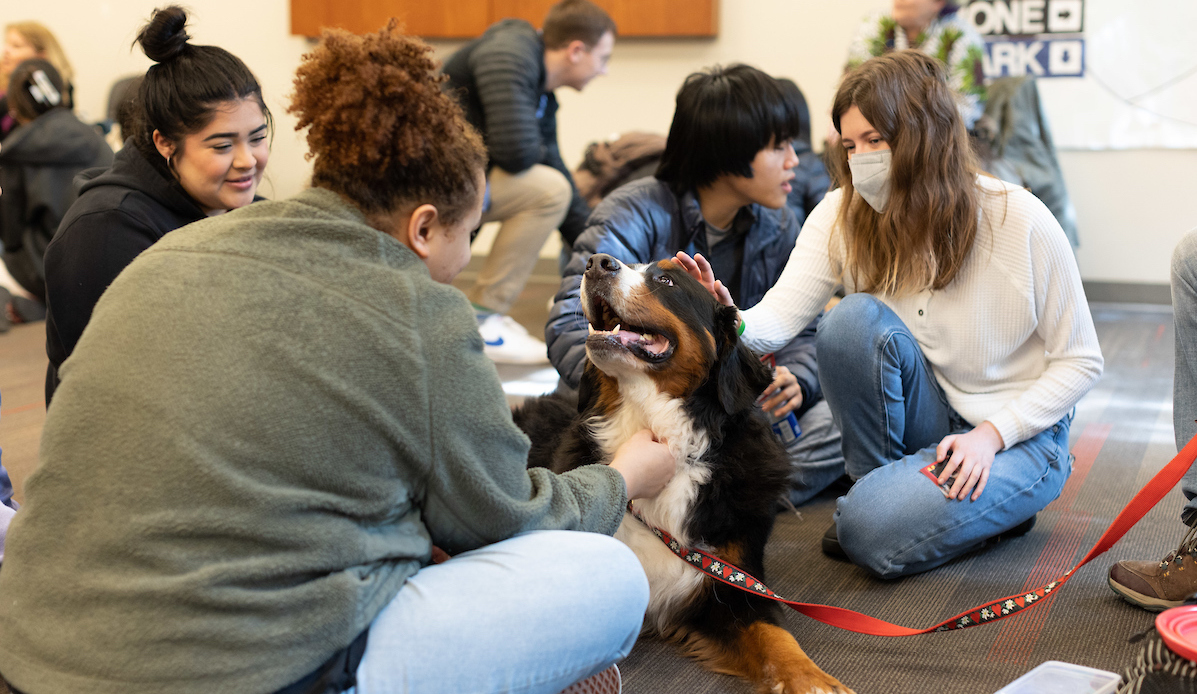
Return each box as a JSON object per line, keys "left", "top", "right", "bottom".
{"left": 679, "top": 50, "right": 1102, "bottom": 578}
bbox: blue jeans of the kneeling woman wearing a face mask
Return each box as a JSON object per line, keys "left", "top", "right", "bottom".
{"left": 818, "top": 294, "right": 1073, "bottom": 578}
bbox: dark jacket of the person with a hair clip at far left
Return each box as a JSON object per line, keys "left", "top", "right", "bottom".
{"left": 0, "top": 109, "right": 113, "bottom": 298}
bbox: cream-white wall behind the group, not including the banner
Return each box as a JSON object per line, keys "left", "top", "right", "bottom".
{"left": 16, "top": 0, "right": 1197, "bottom": 284}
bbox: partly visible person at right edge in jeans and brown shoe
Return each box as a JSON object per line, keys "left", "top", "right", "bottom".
{"left": 1108, "top": 229, "right": 1197, "bottom": 611}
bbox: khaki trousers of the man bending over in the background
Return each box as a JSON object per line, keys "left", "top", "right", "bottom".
{"left": 467, "top": 164, "right": 573, "bottom": 313}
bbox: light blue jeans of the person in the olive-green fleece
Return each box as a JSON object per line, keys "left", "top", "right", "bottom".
{"left": 351, "top": 530, "right": 649, "bottom": 694}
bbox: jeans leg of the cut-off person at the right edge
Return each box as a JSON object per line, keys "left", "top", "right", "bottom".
{"left": 1172, "top": 229, "right": 1197, "bottom": 525}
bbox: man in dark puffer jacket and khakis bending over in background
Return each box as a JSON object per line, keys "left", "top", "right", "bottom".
{"left": 444, "top": 0, "right": 615, "bottom": 364}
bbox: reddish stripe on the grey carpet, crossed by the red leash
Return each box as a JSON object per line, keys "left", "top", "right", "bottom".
{"left": 985, "top": 424, "right": 1113, "bottom": 664}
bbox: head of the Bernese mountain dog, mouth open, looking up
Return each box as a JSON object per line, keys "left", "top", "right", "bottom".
{"left": 582, "top": 254, "right": 771, "bottom": 414}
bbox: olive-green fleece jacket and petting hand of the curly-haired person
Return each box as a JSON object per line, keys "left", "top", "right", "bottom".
{"left": 0, "top": 189, "right": 627, "bottom": 694}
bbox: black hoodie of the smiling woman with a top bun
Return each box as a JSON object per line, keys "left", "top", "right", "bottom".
{"left": 45, "top": 140, "right": 206, "bottom": 406}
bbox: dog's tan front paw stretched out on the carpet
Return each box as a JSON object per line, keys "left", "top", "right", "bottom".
{"left": 683, "top": 622, "right": 852, "bottom": 694}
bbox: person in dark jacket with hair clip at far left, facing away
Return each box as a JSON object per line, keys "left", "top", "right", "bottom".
{"left": 0, "top": 57, "right": 113, "bottom": 329}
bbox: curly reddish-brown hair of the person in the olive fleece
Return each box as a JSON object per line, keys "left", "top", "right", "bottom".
{"left": 287, "top": 19, "right": 486, "bottom": 224}
